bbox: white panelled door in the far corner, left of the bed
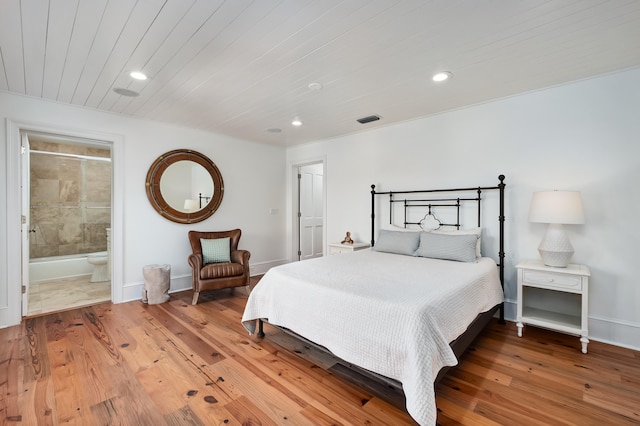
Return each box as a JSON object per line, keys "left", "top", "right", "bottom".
{"left": 298, "top": 163, "right": 324, "bottom": 260}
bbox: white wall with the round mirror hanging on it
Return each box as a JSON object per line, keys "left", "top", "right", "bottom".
{"left": 0, "top": 93, "right": 286, "bottom": 327}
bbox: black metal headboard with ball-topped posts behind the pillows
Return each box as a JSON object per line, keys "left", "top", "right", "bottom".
{"left": 371, "top": 175, "right": 506, "bottom": 322}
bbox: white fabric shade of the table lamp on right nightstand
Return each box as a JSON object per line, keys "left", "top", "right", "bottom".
{"left": 529, "top": 191, "right": 584, "bottom": 225}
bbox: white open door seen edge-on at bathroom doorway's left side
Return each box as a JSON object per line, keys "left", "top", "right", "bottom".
{"left": 20, "top": 133, "right": 31, "bottom": 316}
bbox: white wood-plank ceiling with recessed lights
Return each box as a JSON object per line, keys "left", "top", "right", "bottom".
{"left": 0, "top": 0, "right": 640, "bottom": 146}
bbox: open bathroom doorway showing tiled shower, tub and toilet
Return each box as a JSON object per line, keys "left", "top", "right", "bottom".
{"left": 21, "top": 131, "right": 113, "bottom": 316}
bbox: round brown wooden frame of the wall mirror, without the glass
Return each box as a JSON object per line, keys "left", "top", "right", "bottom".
{"left": 145, "top": 149, "right": 224, "bottom": 223}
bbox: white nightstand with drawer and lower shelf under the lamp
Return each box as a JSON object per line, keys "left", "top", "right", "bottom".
{"left": 516, "top": 260, "right": 591, "bottom": 354}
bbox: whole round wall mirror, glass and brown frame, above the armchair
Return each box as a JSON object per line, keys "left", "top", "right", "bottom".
{"left": 146, "top": 149, "right": 224, "bottom": 223}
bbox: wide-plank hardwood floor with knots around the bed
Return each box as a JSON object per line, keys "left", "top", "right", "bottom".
{"left": 0, "top": 284, "right": 640, "bottom": 426}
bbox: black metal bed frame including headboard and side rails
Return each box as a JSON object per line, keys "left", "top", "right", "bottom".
{"left": 257, "top": 175, "right": 506, "bottom": 389}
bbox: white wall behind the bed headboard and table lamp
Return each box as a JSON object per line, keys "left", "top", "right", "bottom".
{"left": 287, "top": 69, "right": 640, "bottom": 349}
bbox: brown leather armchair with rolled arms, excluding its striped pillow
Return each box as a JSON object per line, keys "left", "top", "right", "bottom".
{"left": 189, "top": 229, "right": 251, "bottom": 305}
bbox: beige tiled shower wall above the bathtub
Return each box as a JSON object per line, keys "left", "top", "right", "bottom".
{"left": 29, "top": 138, "right": 111, "bottom": 259}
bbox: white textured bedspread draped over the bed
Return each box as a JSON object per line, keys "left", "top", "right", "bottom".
{"left": 242, "top": 249, "right": 503, "bottom": 425}
